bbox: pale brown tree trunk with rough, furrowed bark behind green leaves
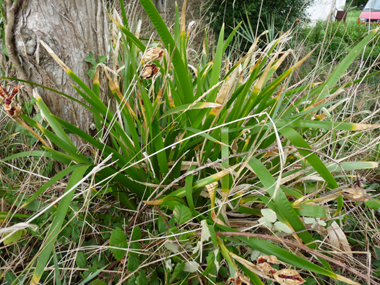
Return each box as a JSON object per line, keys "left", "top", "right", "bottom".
{"left": 6, "top": 0, "right": 108, "bottom": 146}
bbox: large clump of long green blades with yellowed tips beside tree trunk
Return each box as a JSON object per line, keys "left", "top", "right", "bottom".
{"left": 2, "top": 0, "right": 379, "bottom": 284}
